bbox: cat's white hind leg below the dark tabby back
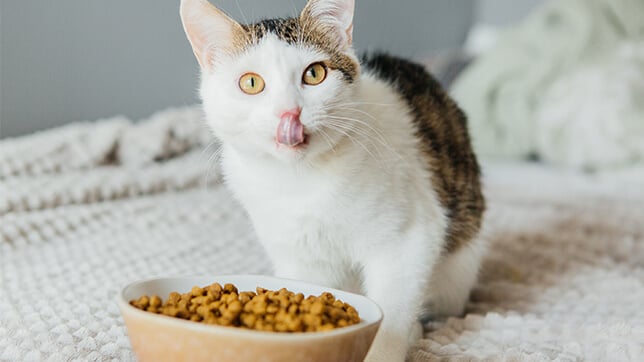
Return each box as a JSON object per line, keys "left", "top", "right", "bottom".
{"left": 423, "top": 237, "right": 485, "bottom": 318}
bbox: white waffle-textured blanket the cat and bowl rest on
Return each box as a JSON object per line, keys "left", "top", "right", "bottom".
{"left": 0, "top": 109, "right": 644, "bottom": 361}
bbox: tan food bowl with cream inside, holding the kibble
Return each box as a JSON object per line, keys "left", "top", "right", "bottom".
{"left": 118, "top": 275, "right": 382, "bottom": 362}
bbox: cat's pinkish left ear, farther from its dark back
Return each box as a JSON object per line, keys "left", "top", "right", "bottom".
{"left": 180, "top": 0, "right": 243, "bottom": 69}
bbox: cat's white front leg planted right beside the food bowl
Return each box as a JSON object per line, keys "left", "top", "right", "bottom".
{"left": 363, "top": 236, "right": 440, "bottom": 362}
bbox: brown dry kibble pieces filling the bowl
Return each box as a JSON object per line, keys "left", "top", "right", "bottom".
{"left": 130, "top": 283, "right": 360, "bottom": 332}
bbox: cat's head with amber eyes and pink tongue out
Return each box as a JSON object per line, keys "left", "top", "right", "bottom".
{"left": 181, "top": 0, "right": 360, "bottom": 162}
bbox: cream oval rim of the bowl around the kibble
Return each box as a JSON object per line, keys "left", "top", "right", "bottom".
{"left": 117, "top": 274, "right": 383, "bottom": 341}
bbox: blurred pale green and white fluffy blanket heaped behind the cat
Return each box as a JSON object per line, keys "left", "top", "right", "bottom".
{"left": 452, "top": 0, "right": 644, "bottom": 169}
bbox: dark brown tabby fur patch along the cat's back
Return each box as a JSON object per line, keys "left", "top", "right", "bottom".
{"left": 361, "top": 53, "right": 485, "bottom": 251}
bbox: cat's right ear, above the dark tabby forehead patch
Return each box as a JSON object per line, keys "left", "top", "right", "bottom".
{"left": 300, "top": 0, "right": 355, "bottom": 51}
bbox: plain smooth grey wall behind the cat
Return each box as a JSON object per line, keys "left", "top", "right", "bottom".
{"left": 0, "top": 0, "right": 475, "bottom": 137}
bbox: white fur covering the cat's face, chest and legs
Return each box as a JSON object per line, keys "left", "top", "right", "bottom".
{"left": 201, "top": 28, "right": 479, "bottom": 362}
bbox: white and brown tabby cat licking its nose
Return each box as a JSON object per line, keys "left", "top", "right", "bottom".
{"left": 180, "top": 0, "right": 485, "bottom": 362}
